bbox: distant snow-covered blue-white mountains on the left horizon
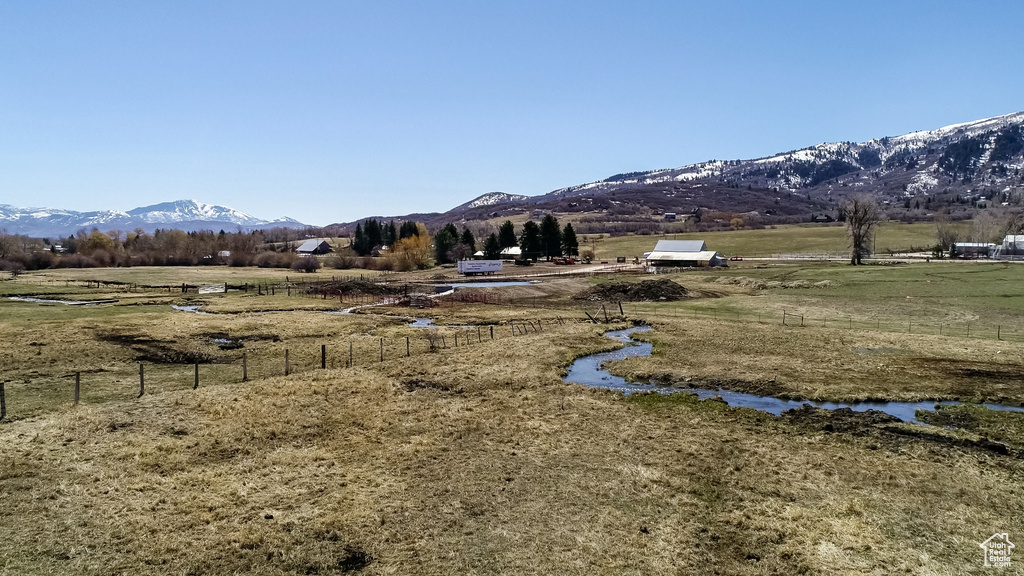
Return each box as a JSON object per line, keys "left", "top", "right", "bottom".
{"left": 0, "top": 200, "right": 305, "bottom": 238}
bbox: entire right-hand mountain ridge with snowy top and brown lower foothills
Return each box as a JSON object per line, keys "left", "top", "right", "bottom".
{"left": 338, "top": 112, "right": 1024, "bottom": 228}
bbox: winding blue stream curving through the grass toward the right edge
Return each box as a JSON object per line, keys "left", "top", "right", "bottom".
{"left": 563, "top": 326, "right": 1024, "bottom": 424}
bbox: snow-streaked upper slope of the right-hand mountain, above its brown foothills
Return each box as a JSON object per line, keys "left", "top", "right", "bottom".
{"left": 532, "top": 112, "right": 1024, "bottom": 202}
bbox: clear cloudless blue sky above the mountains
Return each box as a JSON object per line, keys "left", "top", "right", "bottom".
{"left": 0, "top": 0, "right": 1024, "bottom": 224}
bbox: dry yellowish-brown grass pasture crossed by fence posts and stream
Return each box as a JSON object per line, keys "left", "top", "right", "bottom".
{"left": 0, "top": 264, "right": 1024, "bottom": 575}
